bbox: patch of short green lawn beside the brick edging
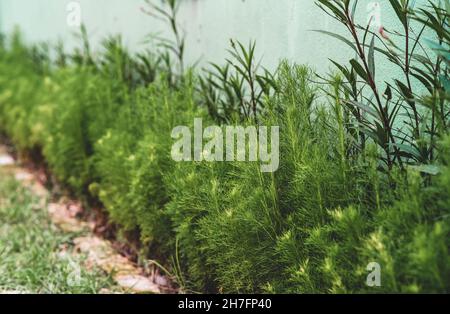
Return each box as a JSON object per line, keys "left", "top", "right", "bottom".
{"left": 0, "top": 173, "right": 118, "bottom": 293}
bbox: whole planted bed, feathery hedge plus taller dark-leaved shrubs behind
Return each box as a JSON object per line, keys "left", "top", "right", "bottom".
{"left": 0, "top": 1, "right": 450, "bottom": 293}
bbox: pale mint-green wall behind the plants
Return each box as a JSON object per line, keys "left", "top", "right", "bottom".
{"left": 0, "top": 0, "right": 426, "bottom": 75}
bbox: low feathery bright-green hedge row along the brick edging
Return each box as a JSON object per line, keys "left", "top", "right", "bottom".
{"left": 0, "top": 34, "right": 450, "bottom": 293}
